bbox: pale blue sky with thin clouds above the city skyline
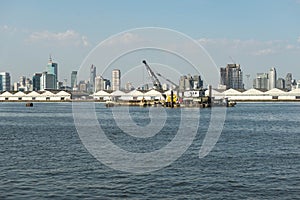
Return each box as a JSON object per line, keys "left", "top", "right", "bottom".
{"left": 0, "top": 0, "right": 300, "bottom": 87}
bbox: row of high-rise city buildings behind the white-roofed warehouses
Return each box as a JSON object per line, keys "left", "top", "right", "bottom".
{"left": 0, "top": 55, "right": 300, "bottom": 92}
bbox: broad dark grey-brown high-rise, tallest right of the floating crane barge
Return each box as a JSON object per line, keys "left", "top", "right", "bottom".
{"left": 220, "top": 64, "right": 244, "bottom": 89}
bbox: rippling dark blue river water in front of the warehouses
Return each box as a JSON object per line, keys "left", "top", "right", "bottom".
{"left": 0, "top": 103, "right": 300, "bottom": 199}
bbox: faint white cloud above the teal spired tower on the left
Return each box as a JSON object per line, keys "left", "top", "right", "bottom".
{"left": 26, "top": 30, "right": 89, "bottom": 46}
